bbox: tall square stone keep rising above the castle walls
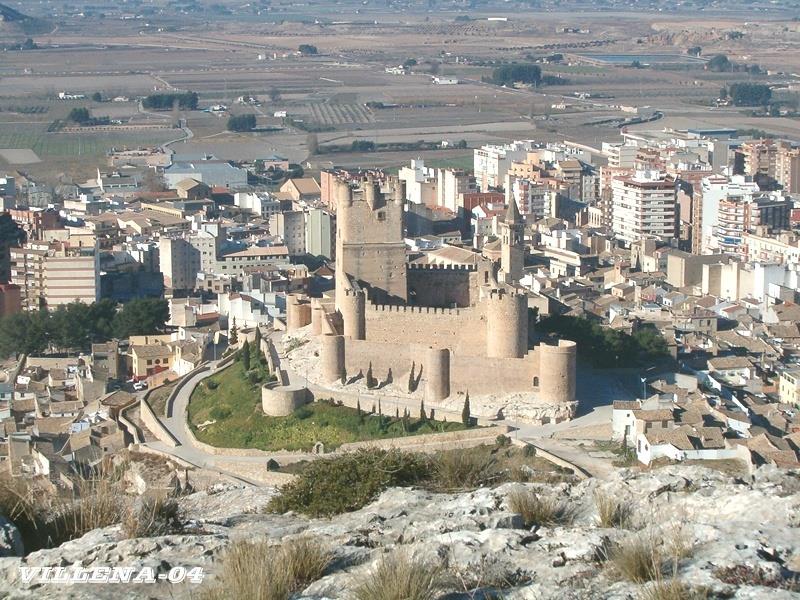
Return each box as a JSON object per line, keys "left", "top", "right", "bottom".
{"left": 335, "top": 177, "right": 408, "bottom": 309}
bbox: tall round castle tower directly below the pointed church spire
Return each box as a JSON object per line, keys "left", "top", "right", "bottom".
{"left": 484, "top": 288, "right": 528, "bottom": 358}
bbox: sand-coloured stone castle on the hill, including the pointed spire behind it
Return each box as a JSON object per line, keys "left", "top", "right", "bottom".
{"left": 278, "top": 177, "right": 576, "bottom": 422}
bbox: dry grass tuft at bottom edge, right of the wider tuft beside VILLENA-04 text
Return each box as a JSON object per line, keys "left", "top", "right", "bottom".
{"left": 353, "top": 552, "right": 443, "bottom": 600}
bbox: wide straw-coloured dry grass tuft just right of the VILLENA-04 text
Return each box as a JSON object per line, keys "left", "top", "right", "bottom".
{"left": 202, "top": 538, "right": 332, "bottom": 600}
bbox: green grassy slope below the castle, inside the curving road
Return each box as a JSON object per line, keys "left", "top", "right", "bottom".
{"left": 189, "top": 362, "right": 463, "bottom": 450}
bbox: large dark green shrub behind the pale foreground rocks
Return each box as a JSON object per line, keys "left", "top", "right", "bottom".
{"left": 268, "top": 450, "right": 429, "bottom": 517}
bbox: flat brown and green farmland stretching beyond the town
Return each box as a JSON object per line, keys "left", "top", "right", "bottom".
{"left": 0, "top": 2, "right": 800, "bottom": 176}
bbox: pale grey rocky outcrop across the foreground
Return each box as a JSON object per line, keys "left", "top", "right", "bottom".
{"left": 0, "top": 466, "right": 800, "bottom": 600}
